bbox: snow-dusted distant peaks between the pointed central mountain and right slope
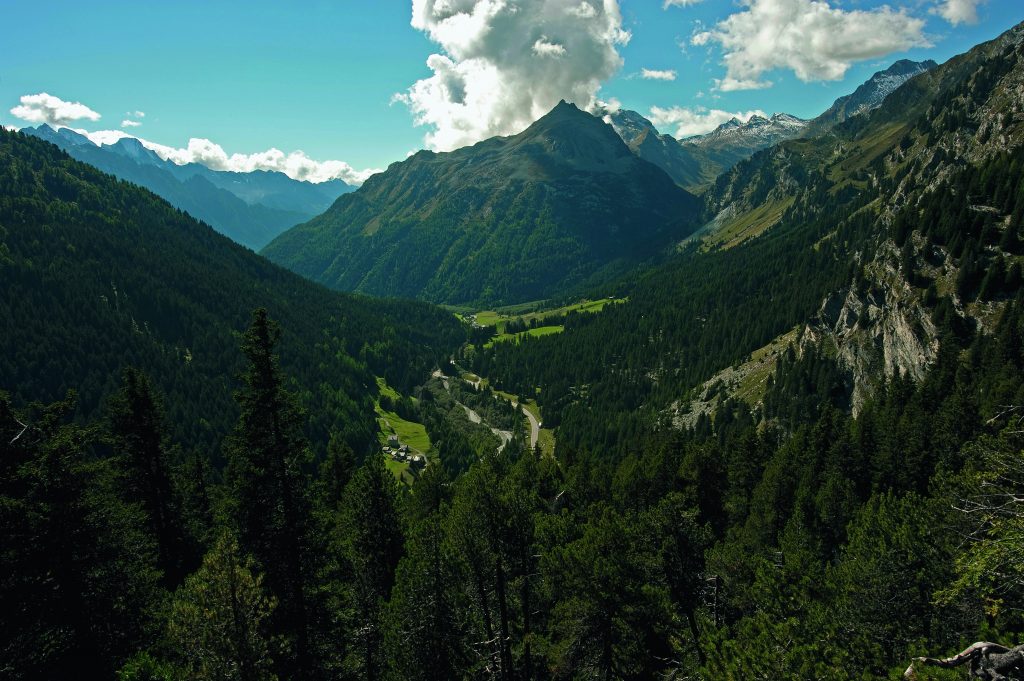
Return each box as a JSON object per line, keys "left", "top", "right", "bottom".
{"left": 604, "top": 59, "right": 936, "bottom": 194}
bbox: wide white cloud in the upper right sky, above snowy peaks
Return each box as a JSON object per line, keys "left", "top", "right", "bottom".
{"left": 690, "top": 0, "right": 929, "bottom": 91}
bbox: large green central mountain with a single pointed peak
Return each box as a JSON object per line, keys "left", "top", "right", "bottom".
{"left": 263, "top": 101, "right": 700, "bottom": 304}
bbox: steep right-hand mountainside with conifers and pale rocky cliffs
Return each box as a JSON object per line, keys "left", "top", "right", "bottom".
{"left": 473, "top": 19, "right": 1024, "bottom": 451}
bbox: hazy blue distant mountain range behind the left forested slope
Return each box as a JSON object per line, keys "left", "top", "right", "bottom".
{"left": 23, "top": 124, "right": 355, "bottom": 250}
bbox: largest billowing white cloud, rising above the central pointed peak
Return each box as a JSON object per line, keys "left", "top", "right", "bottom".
{"left": 394, "top": 0, "right": 630, "bottom": 151}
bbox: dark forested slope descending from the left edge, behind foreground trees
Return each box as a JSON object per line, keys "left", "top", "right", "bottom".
{"left": 0, "top": 131, "right": 462, "bottom": 453}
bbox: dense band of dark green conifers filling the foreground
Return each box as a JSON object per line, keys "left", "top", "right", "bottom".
{"left": 8, "top": 297, "right": 1024, "bottom": 679}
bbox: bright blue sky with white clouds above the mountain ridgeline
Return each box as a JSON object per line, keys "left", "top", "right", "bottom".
{"left": 0, "top": 0, "right": 1024, "bottom": 183}
